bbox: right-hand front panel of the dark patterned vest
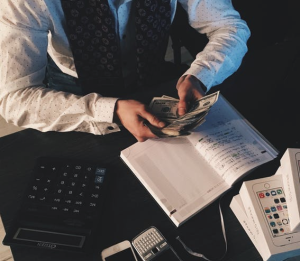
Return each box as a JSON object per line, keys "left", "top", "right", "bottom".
{"left": 135, "top": 0, "right": 171, "bottom": 86}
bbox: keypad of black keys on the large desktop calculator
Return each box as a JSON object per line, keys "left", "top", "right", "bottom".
{"left": 23, "top": 157, "right": 106, "bottom": 224}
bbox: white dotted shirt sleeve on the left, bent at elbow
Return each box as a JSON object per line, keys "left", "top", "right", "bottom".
{"left": 0, "top": 0, "right": 120, "bottom": 134}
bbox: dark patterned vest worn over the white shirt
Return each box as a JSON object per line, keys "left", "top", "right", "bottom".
{"left": 61, "top": 0, "right": 171, "bottom": 97}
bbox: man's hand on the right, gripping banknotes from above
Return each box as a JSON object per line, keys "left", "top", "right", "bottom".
{"left": 176, "top": 75, "right": 205, "bottom": 116}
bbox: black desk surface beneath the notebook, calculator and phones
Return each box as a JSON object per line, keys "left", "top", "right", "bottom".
{"left": 0, "top": 39, "right": 300, "bottom": 261}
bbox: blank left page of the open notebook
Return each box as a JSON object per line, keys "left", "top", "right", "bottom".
{"left": 121, "top": 138, "right": 229, "bottom": 219}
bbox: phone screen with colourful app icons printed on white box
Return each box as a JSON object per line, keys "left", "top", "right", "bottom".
{"left": 256, "top": 187, "right": 291, "bottom": 238}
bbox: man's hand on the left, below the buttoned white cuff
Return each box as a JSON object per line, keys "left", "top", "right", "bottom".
{"left": 115, "top": 100, "right": 165, "bottom": 142}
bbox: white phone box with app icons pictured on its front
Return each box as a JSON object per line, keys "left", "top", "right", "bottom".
{"left": 238, "top": 174, "right": 300, "bottom": 261}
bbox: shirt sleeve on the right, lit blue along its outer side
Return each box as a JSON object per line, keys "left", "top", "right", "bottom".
{"left": 179, "top": 0, "right": 250, "bottom": 91}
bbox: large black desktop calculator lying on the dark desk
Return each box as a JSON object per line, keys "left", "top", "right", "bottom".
{"left": 3, "top": 157, "right": 109, "bottom": 253}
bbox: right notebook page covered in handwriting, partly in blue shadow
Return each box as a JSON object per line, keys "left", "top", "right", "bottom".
{"left": 188, "top": 95, "right": 276, "bottom": 185}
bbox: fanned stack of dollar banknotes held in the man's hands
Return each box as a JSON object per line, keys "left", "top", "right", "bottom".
{"left": 145, "top": 91, "right": 219, "bottom": 138}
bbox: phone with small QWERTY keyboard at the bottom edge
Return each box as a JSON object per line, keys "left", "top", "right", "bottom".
{"left": 132, "top": 226, "right": 182, "bottom": 261}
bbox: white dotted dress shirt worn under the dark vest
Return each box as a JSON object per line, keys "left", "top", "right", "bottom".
{"left": 0, "top": 0, "right": 250, "bottom": 134}
